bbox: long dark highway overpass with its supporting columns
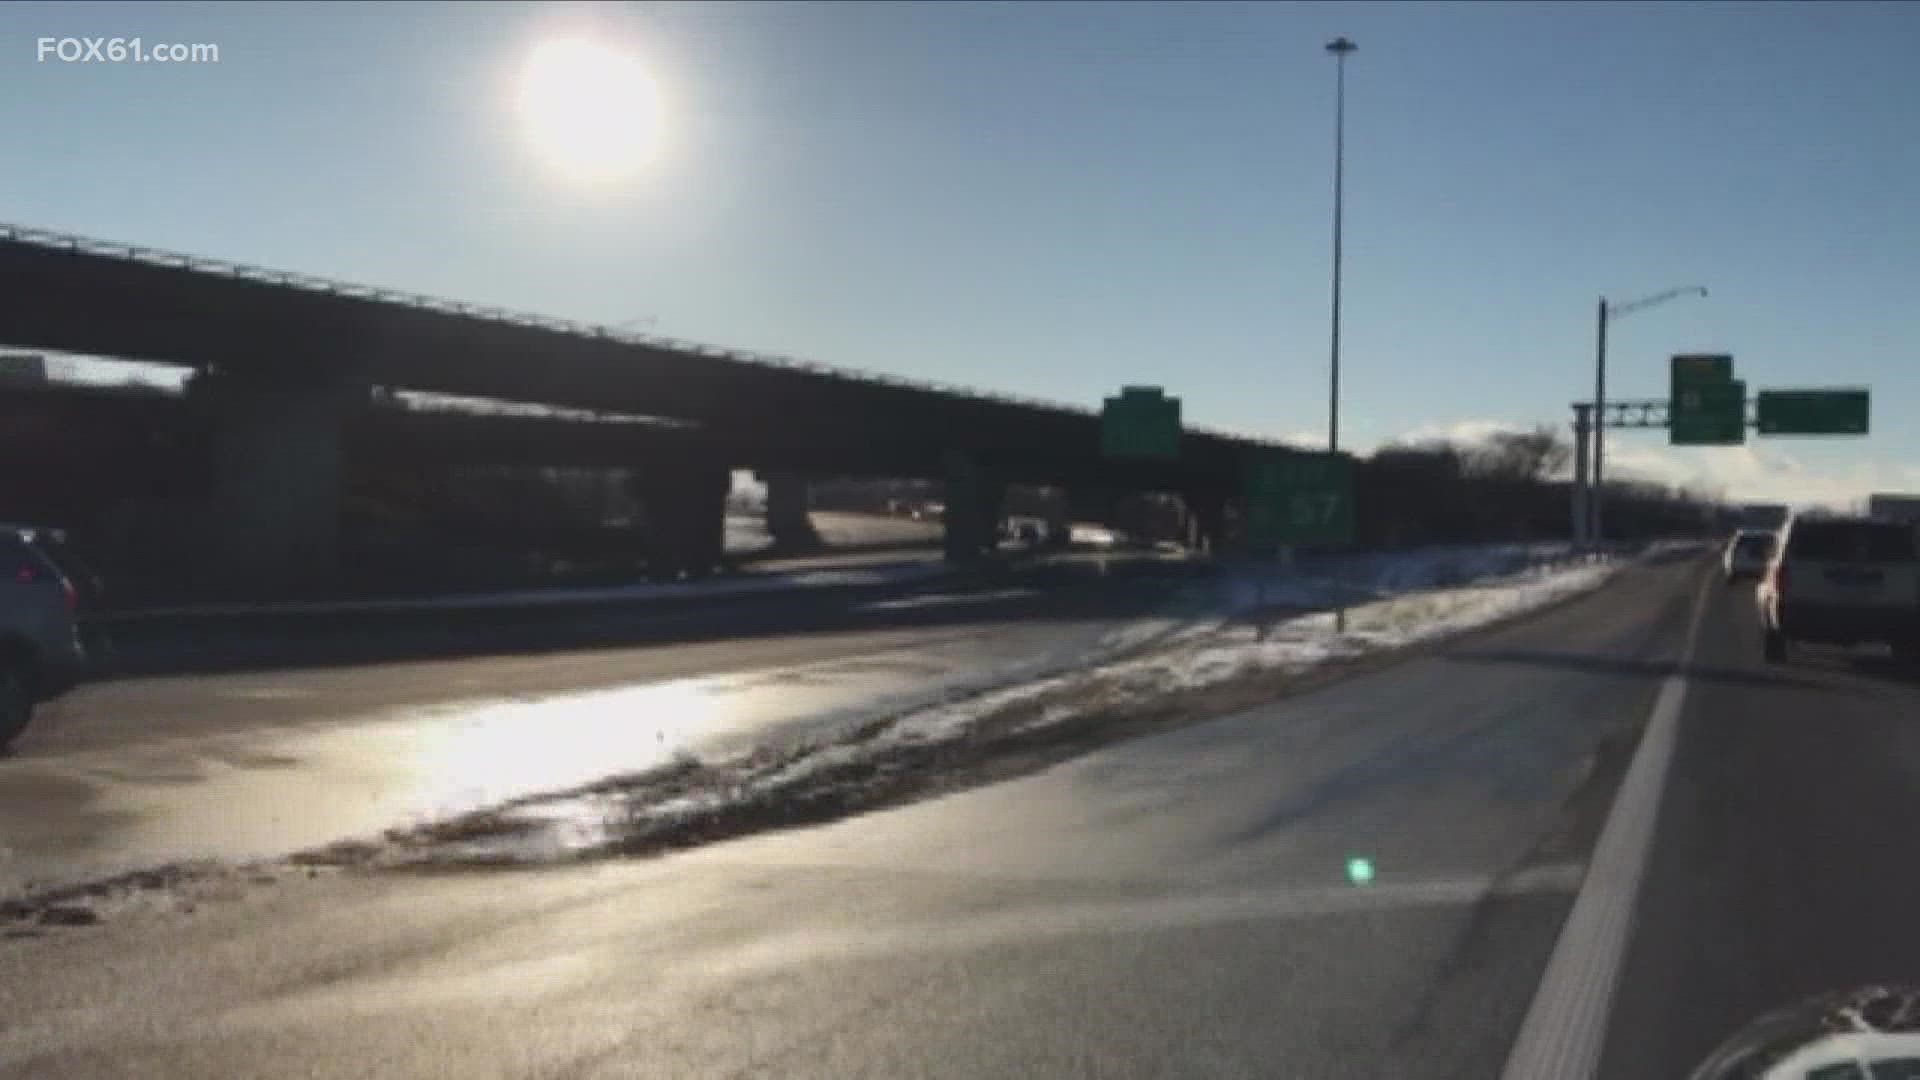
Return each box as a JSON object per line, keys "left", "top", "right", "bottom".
{"left": 0, "top": 225, "right": 1258, "bottom": 588}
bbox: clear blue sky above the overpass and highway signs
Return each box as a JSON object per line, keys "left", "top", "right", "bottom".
{"left": 0, "top": 2, "right": 1920, "bottom": 502}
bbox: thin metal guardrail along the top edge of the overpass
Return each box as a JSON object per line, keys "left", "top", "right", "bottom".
{"left": 0, "top": 223, "right": 1279, "bottom": 446}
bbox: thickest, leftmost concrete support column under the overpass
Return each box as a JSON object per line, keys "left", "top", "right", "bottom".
{"left": 188, "top": 365, "right": 369, "bottom": 596}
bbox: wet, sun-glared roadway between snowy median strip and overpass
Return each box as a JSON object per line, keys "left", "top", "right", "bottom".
{"left": 0, "top": 567, "right": 1179, "bottom": 899}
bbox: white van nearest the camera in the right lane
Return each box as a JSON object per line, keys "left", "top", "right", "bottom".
{"left": 1757, "top": 517, "right": 1920, "bottom": 663}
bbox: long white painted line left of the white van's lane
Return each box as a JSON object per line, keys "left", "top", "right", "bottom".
{"left": 1501, "top": 557, "right": 1713, "bottom": 1080}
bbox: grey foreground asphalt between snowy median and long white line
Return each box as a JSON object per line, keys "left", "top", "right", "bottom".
{"left": 0, "top": 559, "right": 1720, "bottom": 1078}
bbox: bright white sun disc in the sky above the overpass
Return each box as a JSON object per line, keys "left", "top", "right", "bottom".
{"left": 520, "top": 38, "right": 660, "bottom": 183}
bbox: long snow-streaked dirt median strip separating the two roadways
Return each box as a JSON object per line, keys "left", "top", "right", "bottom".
{"left": 0, "top": 544, "right": 1699, "bottom": 924}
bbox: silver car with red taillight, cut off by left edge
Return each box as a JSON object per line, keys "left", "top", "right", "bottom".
{"left": 0, "top": 525, "right": 86, "bottom": 749}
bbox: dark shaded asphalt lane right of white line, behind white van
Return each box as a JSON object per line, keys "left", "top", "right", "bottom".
{"left": 1603, "top": 568, "right": 1920, "bottom": 1080}
